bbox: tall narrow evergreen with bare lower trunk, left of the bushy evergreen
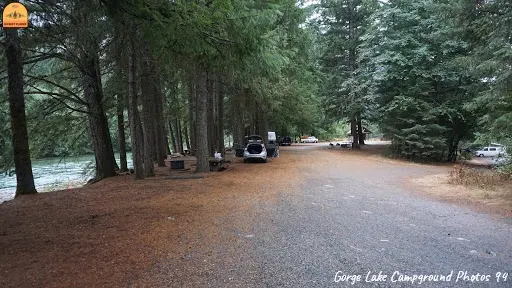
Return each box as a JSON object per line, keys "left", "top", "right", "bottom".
{"left": 320, "top": 0, "right": 377, "bottom": 148}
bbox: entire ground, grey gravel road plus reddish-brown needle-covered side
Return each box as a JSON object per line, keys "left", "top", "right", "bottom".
{"left": 0, "top": 143, "right": 512, "bottom": 288}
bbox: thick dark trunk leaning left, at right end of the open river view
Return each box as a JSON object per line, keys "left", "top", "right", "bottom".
{"left": 81, "top": 49, "right": 117, "bottom": 180}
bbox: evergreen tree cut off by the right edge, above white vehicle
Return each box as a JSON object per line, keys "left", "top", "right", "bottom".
{"left": 458, "top": 0, "right": 512, "bottom": 145}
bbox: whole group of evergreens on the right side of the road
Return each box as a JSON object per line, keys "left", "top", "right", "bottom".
{"left": 312, "top": 0, "right": 512, "bottom": 161}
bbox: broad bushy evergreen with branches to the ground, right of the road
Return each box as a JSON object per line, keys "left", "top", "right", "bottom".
{"left": 360, "top": 0, "right": 478, "bottom": 161}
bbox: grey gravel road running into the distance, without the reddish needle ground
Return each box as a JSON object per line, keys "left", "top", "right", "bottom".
{"left": 153, "top": 144, "right": 512, "bottom": 287}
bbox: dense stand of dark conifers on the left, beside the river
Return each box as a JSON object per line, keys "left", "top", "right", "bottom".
{"left": 0, "top": 0, "right": 321, "bottom": 188}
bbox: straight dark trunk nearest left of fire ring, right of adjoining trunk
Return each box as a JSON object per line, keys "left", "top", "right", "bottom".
{"left": 141, "top": 53, "right": 156, "bottom": 177}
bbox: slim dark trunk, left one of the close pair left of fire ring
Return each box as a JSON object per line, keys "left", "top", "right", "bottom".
{"left": 128, "top": 28, "right": 144, "bottom": 179}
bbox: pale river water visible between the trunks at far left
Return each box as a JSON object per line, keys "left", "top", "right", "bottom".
{"left": 0, "top": 153, "right": 133, "bottom": 203}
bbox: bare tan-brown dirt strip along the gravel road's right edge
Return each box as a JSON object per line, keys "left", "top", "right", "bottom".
{"left": 326, "top": 145, "right": 512, "bottom": 217}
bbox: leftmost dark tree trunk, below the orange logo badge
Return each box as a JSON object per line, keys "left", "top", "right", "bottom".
{"left": 4, "top": 28, "right": 37, "bottom": 197}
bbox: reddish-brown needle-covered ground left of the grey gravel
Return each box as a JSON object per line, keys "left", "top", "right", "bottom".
{"left": 0, "top": 154, "right": 304, "bottom": 287}
